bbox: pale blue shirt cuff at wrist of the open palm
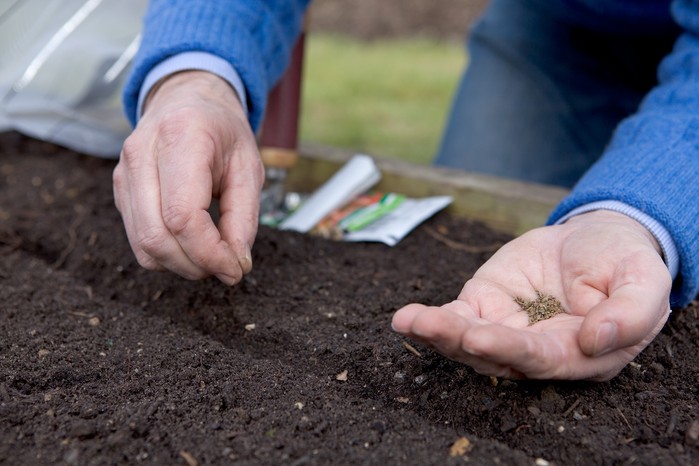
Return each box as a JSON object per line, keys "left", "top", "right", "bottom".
{"left": 556, "top": 201, "right": 680, "bottom": 280}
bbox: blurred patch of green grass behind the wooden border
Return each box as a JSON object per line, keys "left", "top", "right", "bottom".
{"left": 300, "top": 34, "right": 465, "bottom": 163}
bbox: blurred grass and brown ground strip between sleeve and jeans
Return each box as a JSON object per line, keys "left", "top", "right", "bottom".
{"left": 300, "top": 0, "right": 487, "bottom": 164}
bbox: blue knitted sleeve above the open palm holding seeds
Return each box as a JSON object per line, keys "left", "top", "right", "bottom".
{"left": 549, "top": 0, "right": 699, "bottom": 306}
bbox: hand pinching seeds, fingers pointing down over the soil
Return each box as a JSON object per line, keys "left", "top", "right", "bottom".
{"left": 113, "top": 71, "right": 264, "bottom": 285}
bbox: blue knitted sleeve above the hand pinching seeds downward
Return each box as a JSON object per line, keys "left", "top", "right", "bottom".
{"left": 123, "top": 0, "right": 310, "bottom": 131}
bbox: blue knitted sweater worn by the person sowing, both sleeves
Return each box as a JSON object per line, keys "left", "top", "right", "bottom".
{"left": 124, "top": 0, "right": 699, "bottom": 306}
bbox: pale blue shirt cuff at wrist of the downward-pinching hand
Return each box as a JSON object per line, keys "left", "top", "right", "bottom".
{"left": 136, "top": 52, "right": 249, "bottom": 121}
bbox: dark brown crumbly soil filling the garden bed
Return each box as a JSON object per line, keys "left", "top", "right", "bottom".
{"left": 0, "top": 133, "right": 699, "bottom": 465}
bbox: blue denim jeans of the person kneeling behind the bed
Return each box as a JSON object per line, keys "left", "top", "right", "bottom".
{"left": 434, "top": 0, "right": 678, "bottom": 187}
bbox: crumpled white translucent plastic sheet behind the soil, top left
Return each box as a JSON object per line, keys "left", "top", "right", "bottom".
{"left": 0, "top": 0, "right": 147, "bottom": 157}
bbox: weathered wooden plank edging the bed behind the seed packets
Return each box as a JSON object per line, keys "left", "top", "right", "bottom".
{"left": 287, "top": 144, "right": 568, "bottom": 235}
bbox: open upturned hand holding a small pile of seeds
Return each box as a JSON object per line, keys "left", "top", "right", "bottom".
{"left": 392, "top": 210, "right": 671, "bottom": 381}
